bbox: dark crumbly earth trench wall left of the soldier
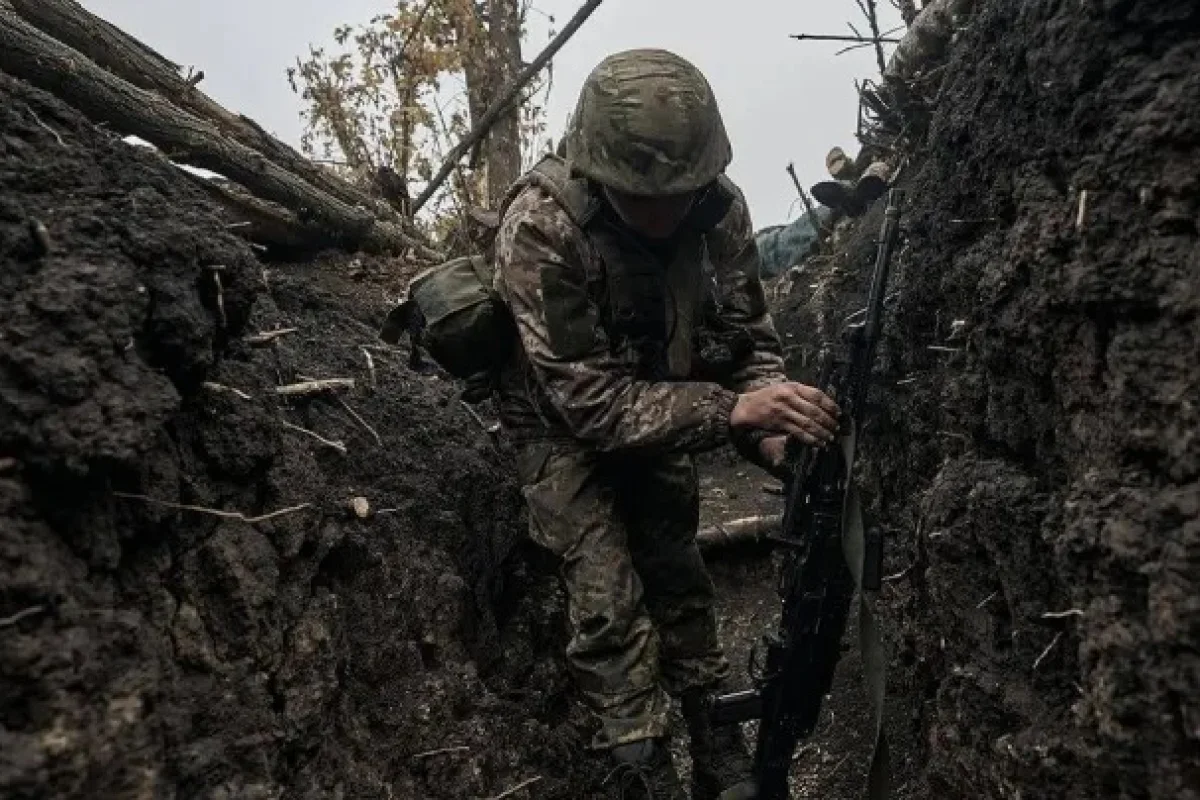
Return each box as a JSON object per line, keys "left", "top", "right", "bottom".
{"left": 0, "top": 74, "right": 600, "bottom": 799}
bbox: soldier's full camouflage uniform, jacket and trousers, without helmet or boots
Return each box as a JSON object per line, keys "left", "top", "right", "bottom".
{"left": 496, "top": 148, "right": 784, "bottom": 746}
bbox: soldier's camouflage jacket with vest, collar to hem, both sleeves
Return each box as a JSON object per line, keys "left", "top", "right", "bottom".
{"left": 496, "top": 157, "right": 785, "bottom": 452}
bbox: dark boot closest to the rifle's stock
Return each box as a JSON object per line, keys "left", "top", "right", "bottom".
{"left": 679, "top": 688, "right": 758, "bottom": 800}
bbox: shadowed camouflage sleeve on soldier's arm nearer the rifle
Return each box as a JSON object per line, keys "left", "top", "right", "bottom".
{"left": 708, "top": 185, "right": 787, "bottom": 392}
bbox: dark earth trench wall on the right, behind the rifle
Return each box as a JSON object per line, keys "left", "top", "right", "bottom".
{"left": 782, "top": 0, "right": 1200, "bottom": 799}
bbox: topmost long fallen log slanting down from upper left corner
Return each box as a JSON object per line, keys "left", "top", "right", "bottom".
{"left": 7, "top": 0, "right": 422, "bottom": 239}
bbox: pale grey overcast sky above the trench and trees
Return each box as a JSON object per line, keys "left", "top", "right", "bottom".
{"left": 83, "top": 0, "right": 898, "bottom": 227}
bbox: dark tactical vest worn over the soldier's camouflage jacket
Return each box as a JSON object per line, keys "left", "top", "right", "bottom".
{"left": 502, "top": 156, "right": 734, "bottom": 380}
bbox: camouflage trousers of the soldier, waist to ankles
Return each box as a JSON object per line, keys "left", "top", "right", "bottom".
{"left": 517, "top": 443, "right": 728, "bottom": 747}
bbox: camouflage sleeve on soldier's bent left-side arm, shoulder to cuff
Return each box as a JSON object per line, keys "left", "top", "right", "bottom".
{"left": 496, "top": 190, "right": 737, "bottom": 452}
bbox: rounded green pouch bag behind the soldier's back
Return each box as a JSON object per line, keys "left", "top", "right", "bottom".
{"left": 379, "top": 255, "right": 516, "bottom": 380}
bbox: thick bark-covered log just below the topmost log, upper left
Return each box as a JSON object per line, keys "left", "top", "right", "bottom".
{"left": 0, "top": 0, "right": 440, "bottom": 260}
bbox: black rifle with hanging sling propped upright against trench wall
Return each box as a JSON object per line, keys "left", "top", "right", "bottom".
{"left": 709, "top": 190, "right": 904, "bottom": 800}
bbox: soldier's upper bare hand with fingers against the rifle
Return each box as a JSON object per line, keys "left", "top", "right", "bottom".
{"left": 730, "top": 383, "right": 840, "bottom": 445}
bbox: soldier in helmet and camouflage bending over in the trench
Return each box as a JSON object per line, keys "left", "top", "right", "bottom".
{"left": 496, "top": 50, "right": 838, "bottom": 800}
